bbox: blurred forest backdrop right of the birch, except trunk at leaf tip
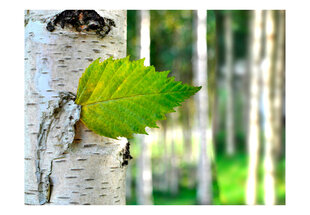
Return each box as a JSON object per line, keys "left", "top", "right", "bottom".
{"left": 127, "top": 10, "right": 285, "bottom": 204}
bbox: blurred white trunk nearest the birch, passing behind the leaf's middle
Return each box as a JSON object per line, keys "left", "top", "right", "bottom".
{"left": 137, "top": 10, "right": 153, "bottom": 205}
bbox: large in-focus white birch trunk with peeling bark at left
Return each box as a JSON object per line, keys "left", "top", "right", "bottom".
{"left": 24, "top": 10, "right": 127, "bottom": 205}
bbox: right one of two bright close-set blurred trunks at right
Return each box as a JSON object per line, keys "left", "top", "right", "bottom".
{"left": 262, "top": 10, "right": 275, "bottom": 205}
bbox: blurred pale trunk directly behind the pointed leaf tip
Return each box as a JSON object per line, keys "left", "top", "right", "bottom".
{"left": 194, "top": 10, "right": 212, "bottom": 204}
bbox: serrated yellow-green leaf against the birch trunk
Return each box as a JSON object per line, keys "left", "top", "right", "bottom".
{"left": 75, "top": 57, "right": 201, "bottom": 139}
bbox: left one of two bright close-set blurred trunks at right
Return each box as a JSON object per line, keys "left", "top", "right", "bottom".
{"left": 246, "top": 10, "right": 263, "bottom": 205}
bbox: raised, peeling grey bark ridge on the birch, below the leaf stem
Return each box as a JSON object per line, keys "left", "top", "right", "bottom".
{"left": 36, "top": 92, "right": 81, "bottom": 204}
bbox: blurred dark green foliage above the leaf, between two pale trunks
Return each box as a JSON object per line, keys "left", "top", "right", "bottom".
{"left": 150, "top": 10, "right": 194, "bottom": 83}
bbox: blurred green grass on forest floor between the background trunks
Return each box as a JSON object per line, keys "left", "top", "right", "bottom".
{"left": 127, "top": 149, "right": 285, "bottom": 205}
